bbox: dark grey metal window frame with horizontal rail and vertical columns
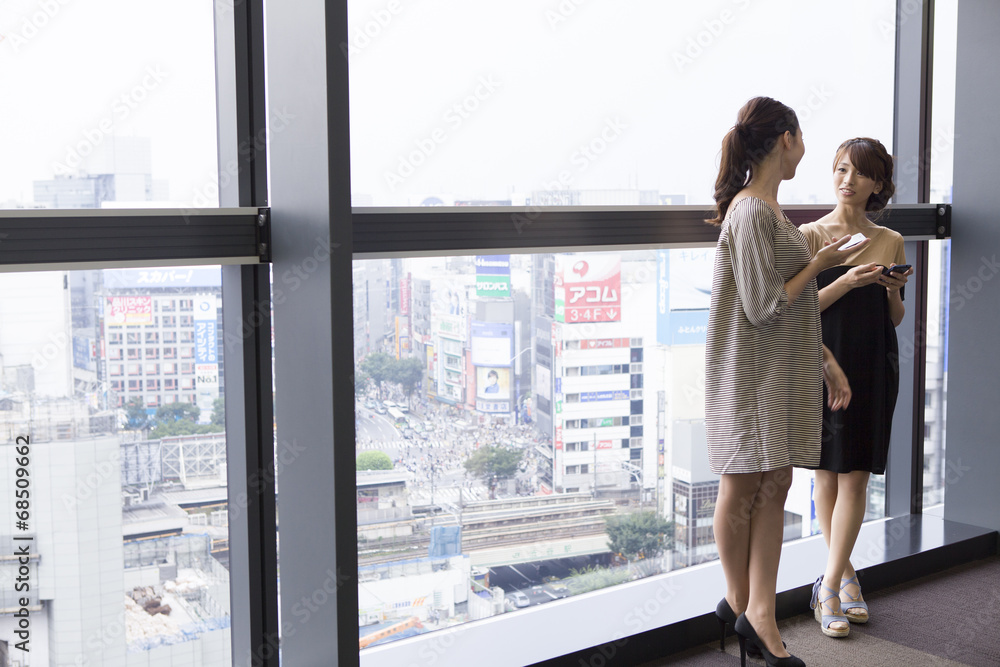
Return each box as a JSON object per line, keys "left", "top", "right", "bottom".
{"left": 0, "top": 0, "right": 951, "bottom": 665}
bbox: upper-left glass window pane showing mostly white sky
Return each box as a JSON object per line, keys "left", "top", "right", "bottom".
{"left": 0, "top": 0, "right": 219, "bottom": 209}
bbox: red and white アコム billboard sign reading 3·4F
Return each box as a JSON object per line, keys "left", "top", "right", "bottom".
{"left": 555, "top": 254, "right": 622, "bottom": 324}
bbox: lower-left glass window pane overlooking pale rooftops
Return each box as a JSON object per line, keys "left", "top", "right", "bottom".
{"left": 0, "top": 268, "right": 232, "bottom": 667}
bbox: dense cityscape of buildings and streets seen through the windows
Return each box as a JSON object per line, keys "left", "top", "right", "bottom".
{"left": 0, "top": 128, "right": 948, "bottom": 665}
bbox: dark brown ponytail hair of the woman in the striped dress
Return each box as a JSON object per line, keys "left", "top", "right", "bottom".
{"left": 705, "top": 97, "right": 799, "bottom": 225}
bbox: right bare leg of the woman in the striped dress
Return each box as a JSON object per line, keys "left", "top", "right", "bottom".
{"left": 746, "top": 466, "right": 792, "bottom": 658}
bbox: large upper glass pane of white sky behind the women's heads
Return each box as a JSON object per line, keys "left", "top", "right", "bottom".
{"left": 347, "top": 0, "right": 896, "bottom": 206}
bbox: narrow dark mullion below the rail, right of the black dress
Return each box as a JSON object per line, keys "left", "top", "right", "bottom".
{"left": 907, "top": 241, "right": 930, "bottom": 514}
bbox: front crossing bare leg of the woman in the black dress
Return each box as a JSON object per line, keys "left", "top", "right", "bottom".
{"left": 823, "top": 470, "right": 870, "bottom": 630}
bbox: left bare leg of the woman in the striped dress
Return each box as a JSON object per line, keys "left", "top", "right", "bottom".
{"left": 713, "top": 473, "right": 762, "bottom": 615}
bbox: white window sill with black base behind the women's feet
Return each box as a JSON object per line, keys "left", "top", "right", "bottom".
{"left": 361, "top": 515, "right": 997, "bottom": 667}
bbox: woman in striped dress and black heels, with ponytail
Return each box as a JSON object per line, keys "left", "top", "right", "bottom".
{"left": 705, "top": 97, "right": 859, "bottom": 667}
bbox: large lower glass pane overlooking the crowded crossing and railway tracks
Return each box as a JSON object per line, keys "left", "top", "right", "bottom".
{"left": 354, "top": 248, "right": 885, "bottom": 641}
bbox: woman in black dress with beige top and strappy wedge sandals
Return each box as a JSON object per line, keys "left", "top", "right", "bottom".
{"left": 800, "top": 138, "right": 913, "bottom": 637}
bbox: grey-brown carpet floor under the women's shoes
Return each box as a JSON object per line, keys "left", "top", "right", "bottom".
{"left": 641, "top": 557, "right": 1000, "bottom": 667}
